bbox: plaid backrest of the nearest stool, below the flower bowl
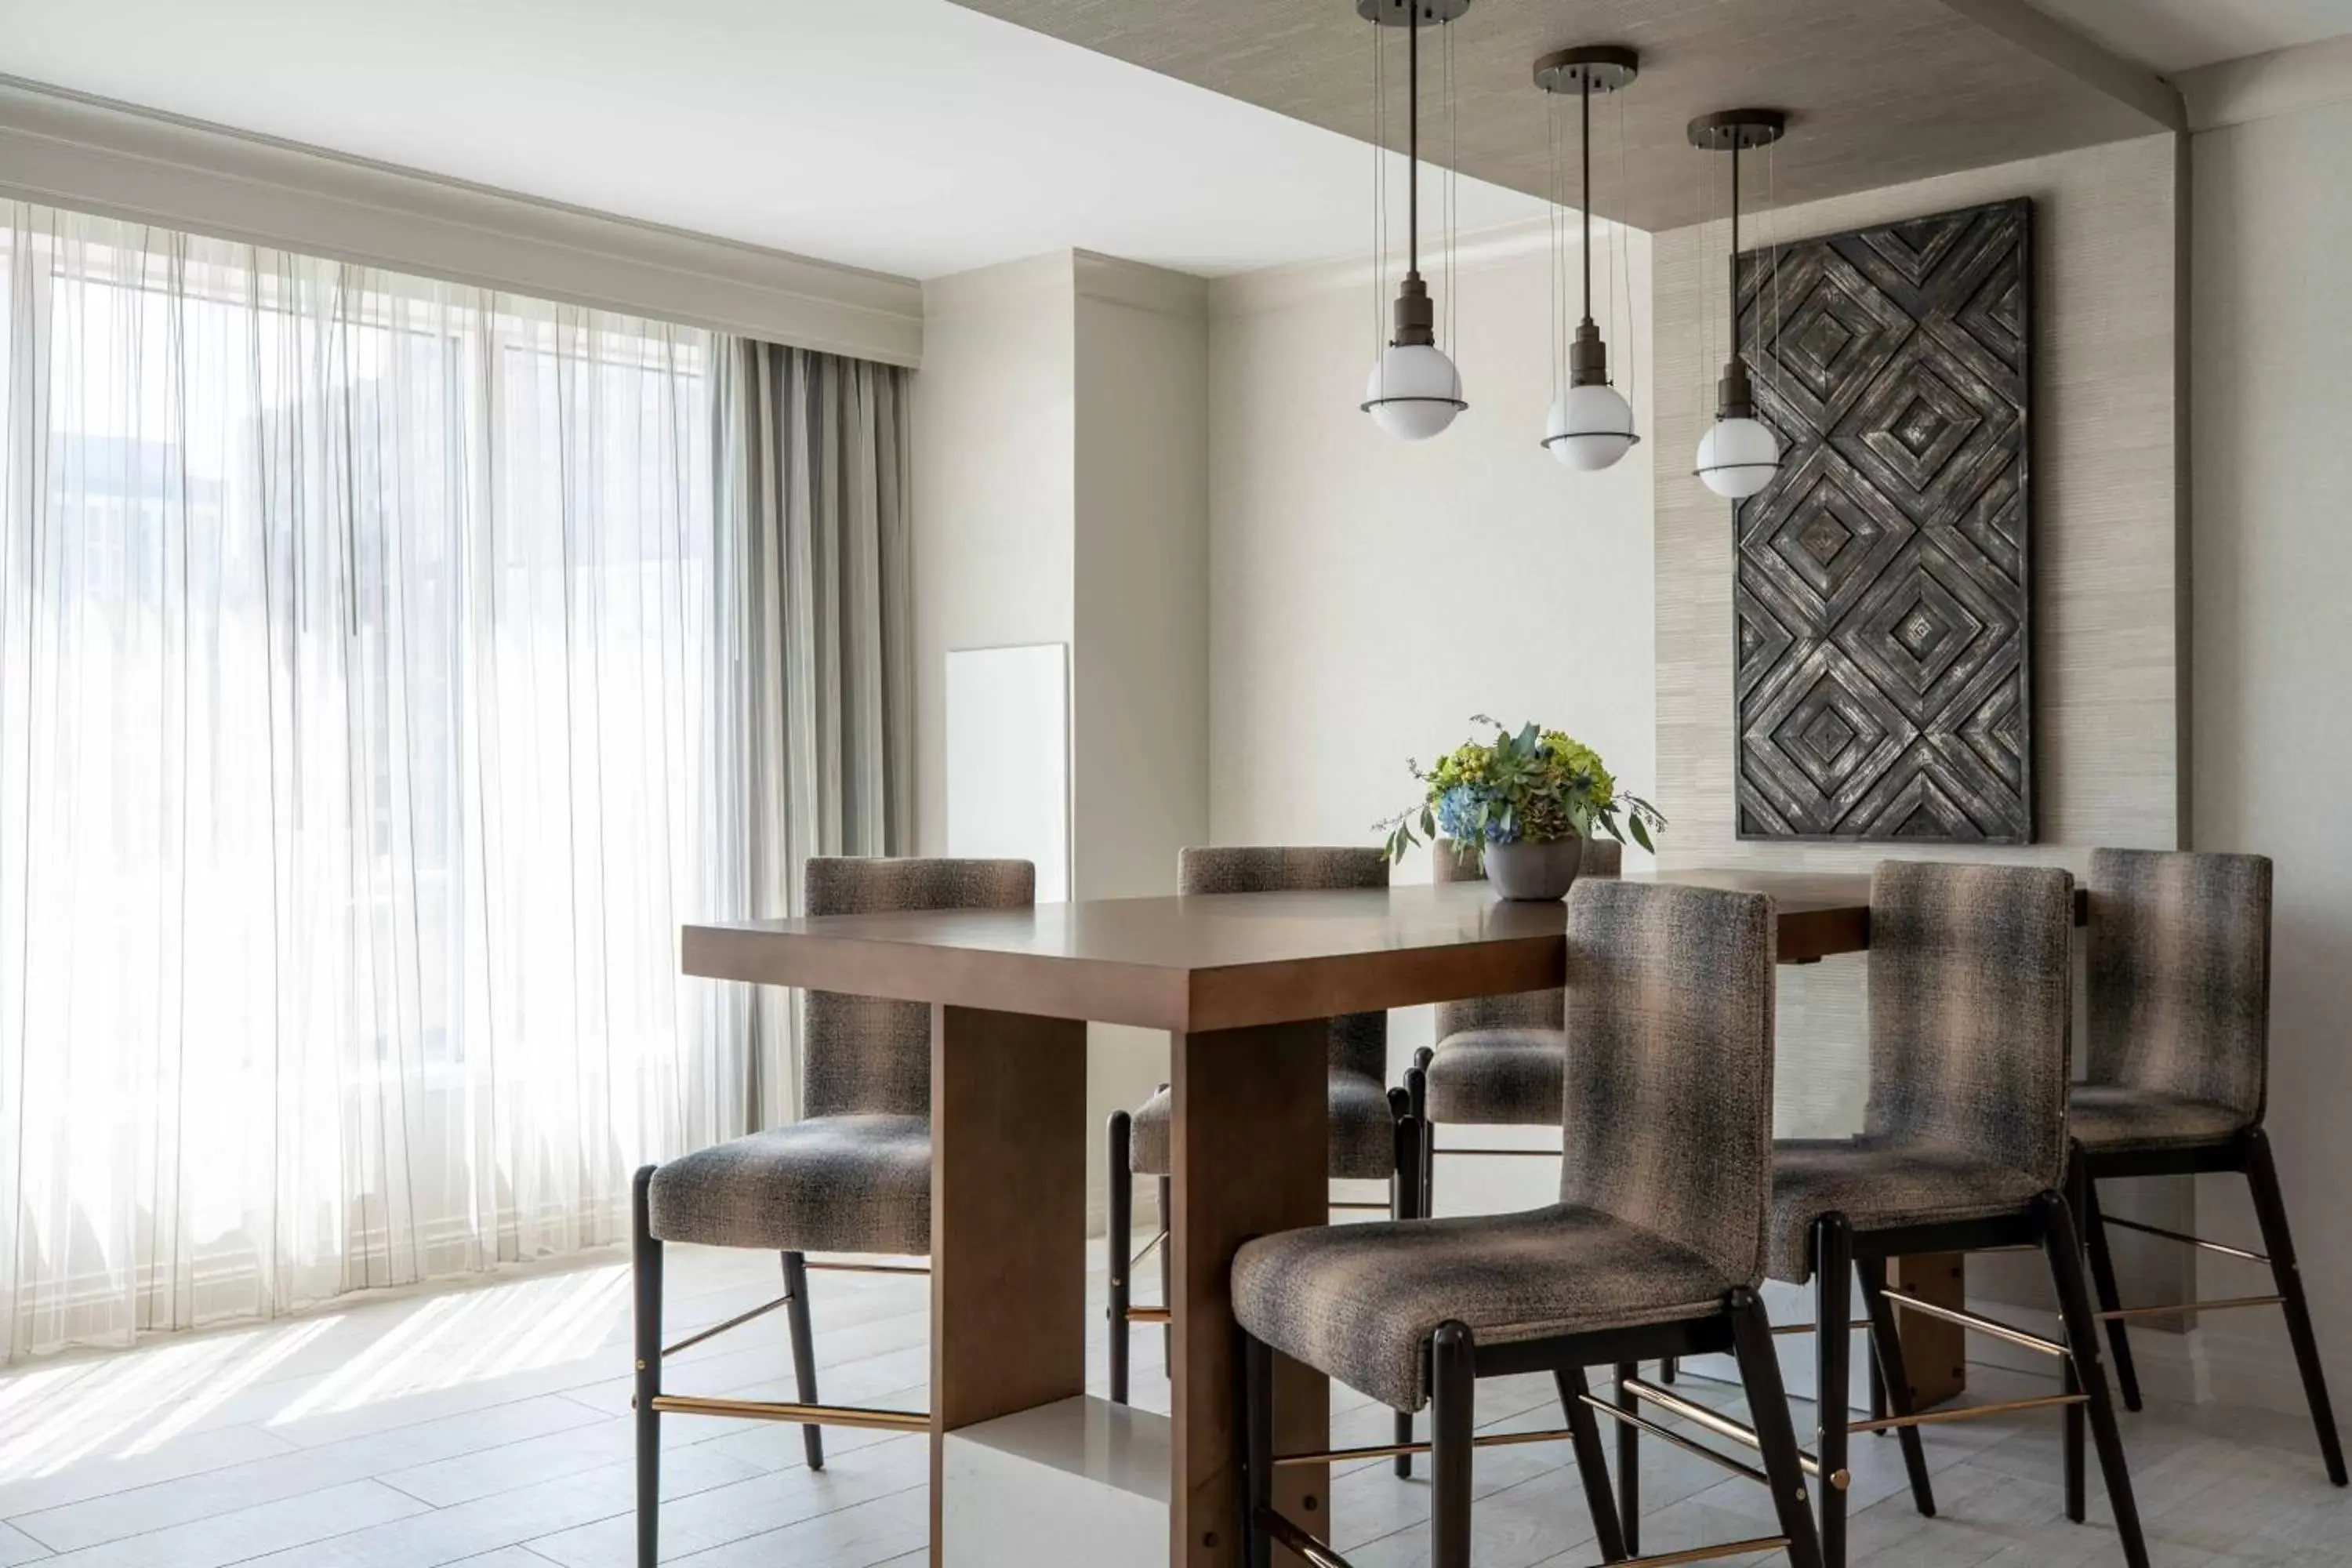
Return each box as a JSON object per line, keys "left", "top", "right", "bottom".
{"left": 1559, "top": 877, "right": 1776, "bottom": 1286}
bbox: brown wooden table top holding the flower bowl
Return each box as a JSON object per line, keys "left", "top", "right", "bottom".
{"left": 682, "top": 867, "right": 2004, "bottom": 1032}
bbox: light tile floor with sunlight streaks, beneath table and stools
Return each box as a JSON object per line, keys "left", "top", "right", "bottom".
{"left": 0, "top": 1248, "right": 2352, "bottom": 1568}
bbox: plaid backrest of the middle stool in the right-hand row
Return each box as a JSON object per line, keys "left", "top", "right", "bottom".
{"left": 1863, "top": 860, "right": 2074, "bottom": 1189}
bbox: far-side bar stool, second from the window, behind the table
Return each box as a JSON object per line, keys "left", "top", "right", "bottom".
{"left": 1108, "top": 846, "right": 1421, "bottom": 1474}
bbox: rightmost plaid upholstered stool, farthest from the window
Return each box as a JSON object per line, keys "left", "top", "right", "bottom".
{"left": 2067, "top": 848, "right": 2345, "bottom": 1486}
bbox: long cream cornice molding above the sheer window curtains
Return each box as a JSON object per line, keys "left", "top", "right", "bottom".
{"left": 0, "top": 75, "right": 922, "bottom": 365}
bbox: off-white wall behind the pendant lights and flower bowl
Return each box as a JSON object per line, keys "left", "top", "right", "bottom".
{"left": 1209, "top": 230, "right": 1675, "bottom": 1208}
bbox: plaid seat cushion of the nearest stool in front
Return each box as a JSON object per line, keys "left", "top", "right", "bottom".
{"left": 1232, "top": 1203, "right": 1743, "bottom": 1410}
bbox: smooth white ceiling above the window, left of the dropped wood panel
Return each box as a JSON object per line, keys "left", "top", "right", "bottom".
{"left": 0, "top": 0, "right": 1541, "bottom": 278}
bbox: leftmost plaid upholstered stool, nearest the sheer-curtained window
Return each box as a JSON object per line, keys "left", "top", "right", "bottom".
{"left": 633, "top": 855, "right": 1037, "bottom": 1568}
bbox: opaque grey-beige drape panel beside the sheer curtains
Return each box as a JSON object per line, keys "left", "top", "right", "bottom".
{"left": 720, "top": 339, "right": 915, "bottom": 1123}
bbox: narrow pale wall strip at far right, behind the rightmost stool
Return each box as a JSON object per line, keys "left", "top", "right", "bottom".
{"left": 2190, "top": 79, "right": 2352, "bottom": 1410}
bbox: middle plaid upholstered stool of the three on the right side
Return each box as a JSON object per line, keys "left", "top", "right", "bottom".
{"left": 1769, "top": 860, "right": 2147, "bottom": 1568}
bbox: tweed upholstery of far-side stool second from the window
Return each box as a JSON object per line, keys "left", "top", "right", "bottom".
{"left": 1127, "top": 844, "right": 1397, "bottom": 1180}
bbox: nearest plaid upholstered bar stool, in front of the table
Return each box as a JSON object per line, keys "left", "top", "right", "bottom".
{"left": 1232, "top": 879, "right": 1844, "bottom": 1568}
